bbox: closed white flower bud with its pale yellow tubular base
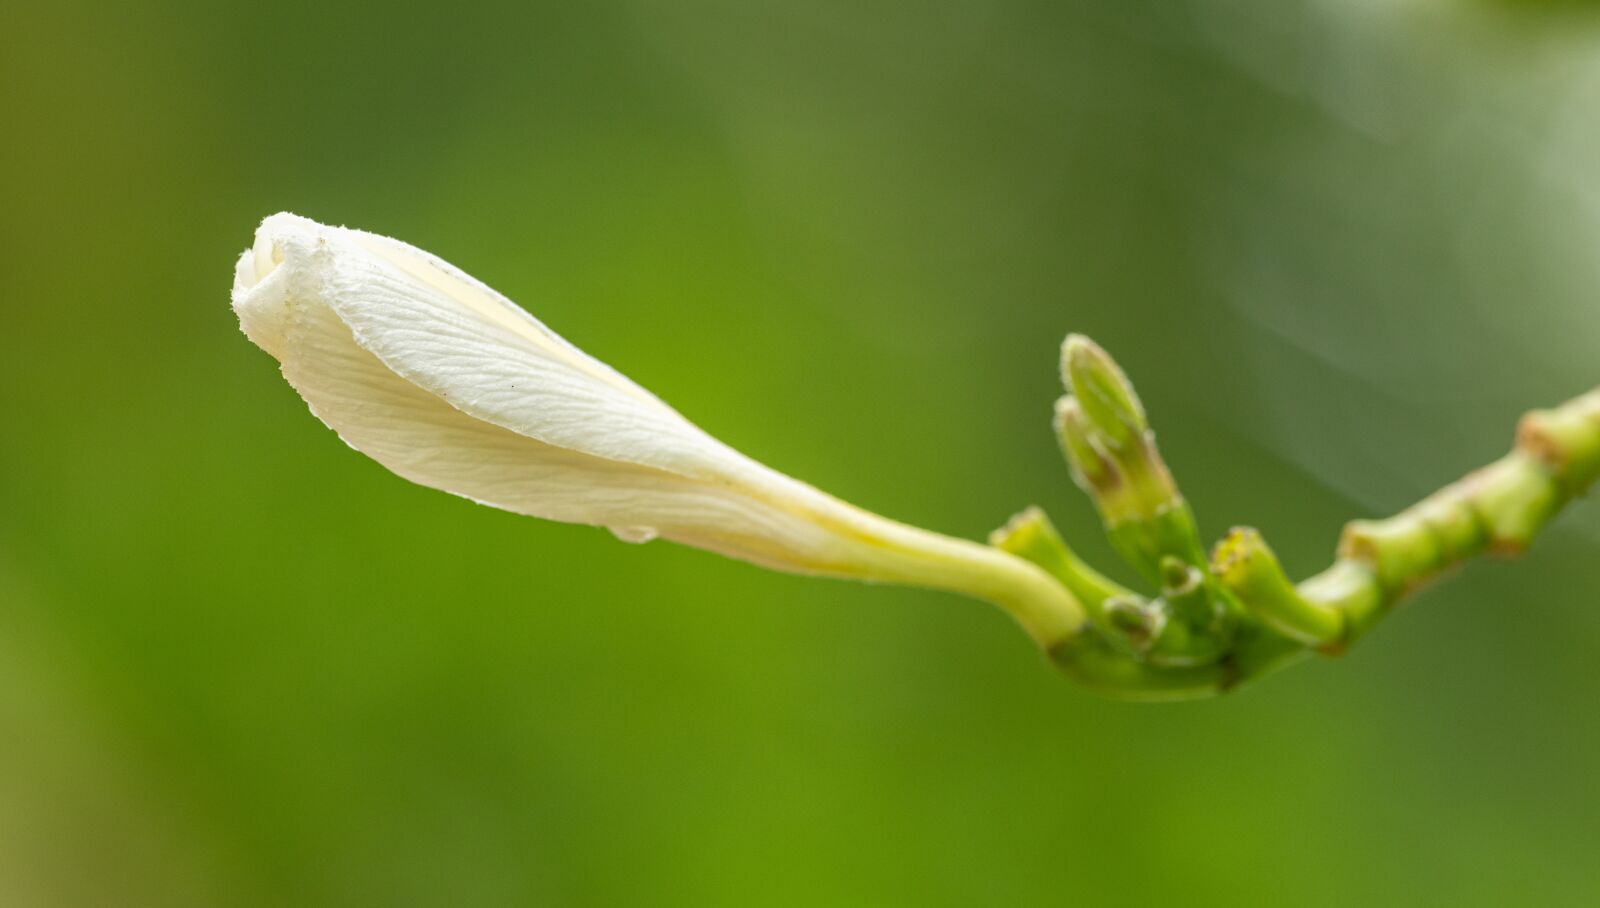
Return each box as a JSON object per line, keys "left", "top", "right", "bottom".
{"left": 234, "top": 214, "right": 1083, "bottom": 647}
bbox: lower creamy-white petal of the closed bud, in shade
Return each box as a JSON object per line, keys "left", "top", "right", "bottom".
{"left": 235, "top": 222, "right": 834, "bottom": 556}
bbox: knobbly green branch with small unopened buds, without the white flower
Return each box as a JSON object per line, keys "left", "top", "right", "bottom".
{"left": 989, "top": 336, "right": 1600, "bottom": 700}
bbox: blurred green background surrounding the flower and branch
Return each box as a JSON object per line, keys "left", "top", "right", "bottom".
{"left": 0, "top": 0, "right": 1600, "bottom": 908}
